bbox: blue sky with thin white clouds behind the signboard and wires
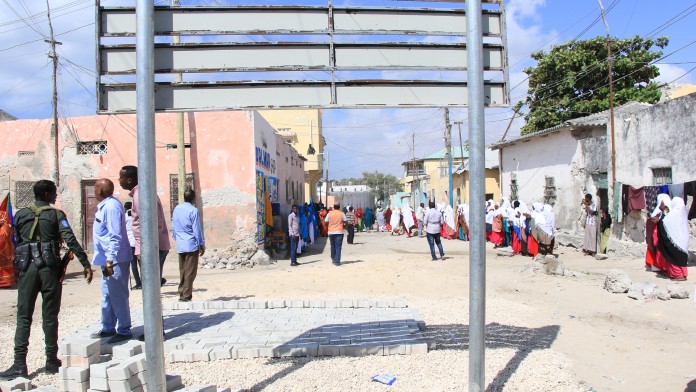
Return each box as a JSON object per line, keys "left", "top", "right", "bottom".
{"left": 0, "top": 0, "right": 696, "bottom": 179}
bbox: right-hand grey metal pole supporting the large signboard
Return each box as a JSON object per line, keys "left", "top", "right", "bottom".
{"left": 466, "top": 0, "right": 486, "bottom": 392}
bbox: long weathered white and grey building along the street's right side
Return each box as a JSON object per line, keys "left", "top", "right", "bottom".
{"left": 491, "top": 93, "right": 696, "bottom": 256}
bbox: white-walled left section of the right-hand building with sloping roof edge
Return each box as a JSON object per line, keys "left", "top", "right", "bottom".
{"left": 491, "top": 103, "right": 649, "bottom": 231}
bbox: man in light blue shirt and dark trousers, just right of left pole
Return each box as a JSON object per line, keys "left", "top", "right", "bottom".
{"left": 172, "top": 188, "right": 205, "bottom": 302}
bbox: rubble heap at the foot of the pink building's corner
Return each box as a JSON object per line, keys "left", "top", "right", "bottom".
{"left": 198, "top": 238, "right": 276, "bottom": 270}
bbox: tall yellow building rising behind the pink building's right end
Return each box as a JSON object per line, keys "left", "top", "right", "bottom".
{"left": 259, "top": 109, "right": 325, "bottom": 203}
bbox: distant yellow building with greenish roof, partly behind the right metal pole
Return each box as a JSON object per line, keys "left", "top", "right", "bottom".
{"left": 401, "top": 147, "right": 500, "bottom": 208}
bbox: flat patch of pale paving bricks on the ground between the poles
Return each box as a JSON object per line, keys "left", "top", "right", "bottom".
{"left": 164, "top": 300, "right": 435, "bottom": 362}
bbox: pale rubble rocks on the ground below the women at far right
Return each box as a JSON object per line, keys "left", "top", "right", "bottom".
{"left": 604, "top": 269, "right": 689, "bottom": 301}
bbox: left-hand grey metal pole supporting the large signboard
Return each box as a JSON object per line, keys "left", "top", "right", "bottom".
{"left": 135, "top": 0, "right": 167, "bottom": 391}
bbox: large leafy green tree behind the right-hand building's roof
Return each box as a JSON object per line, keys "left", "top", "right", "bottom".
{"left": 518, "top": 36, "right": 669, "bottom": 135}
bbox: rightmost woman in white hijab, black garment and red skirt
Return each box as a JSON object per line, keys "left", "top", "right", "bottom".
{"left": 657, "top": 197, "right": 689, "bottom": 281}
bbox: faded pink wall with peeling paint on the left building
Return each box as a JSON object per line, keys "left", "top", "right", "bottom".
{"left": 0, "top": 111, "right": 304, "bottom": 250}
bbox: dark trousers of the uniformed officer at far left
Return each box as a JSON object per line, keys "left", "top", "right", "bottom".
{"left": 15, "top": 262, "right": 63, "bottom": 362}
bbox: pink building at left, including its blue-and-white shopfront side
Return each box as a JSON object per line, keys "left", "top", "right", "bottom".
{"left": 0, "top": 111, "right": 305, "bottom": 250}
